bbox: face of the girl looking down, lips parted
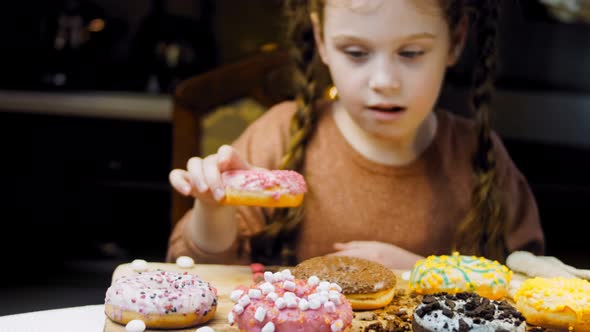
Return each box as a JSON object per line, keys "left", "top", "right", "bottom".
{"left": 312, "top": 0, "right": 456, "bottom": 140}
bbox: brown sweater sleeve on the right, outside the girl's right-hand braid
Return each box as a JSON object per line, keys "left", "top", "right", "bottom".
{"left": 492, "top": 134, "right": 545, "bottom": 255}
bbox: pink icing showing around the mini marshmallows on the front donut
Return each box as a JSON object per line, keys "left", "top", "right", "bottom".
{"left": 232, "top": 279, "right": 353, "bottom": 332}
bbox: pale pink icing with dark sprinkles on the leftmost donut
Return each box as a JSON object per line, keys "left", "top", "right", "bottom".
{"left": 105, "top": 270, "right": 217, "bottom": 316}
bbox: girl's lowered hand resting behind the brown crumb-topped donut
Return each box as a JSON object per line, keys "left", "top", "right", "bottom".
{"left": 332, "top": 241, "right": 423, "bottom": 270}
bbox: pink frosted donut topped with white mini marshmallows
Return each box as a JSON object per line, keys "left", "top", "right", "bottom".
{"left": 227, "top": 270, "right": 353, "bottom": 332}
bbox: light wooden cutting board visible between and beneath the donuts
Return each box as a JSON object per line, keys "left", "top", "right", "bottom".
{"left": 104, "top": 263, "right": 413, "bottom": 332}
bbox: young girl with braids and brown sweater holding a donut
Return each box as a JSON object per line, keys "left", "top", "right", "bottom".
{"left": 167, "top": 0, "right": 544, "bottom": 268}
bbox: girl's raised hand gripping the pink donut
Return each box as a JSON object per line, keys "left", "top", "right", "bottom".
{"left": 168, "top": 145, "right": 252, "bottom": 204}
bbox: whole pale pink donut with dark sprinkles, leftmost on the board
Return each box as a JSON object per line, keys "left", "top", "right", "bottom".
{"left": 105, "top": 270, "right": 217, "bottom": 329}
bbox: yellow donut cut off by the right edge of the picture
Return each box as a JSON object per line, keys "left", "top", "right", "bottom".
{"left": 514, "top": 277, "right": 590, "bottom": 332}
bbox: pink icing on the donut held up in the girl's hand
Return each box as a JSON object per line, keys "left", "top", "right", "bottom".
{"left": 221, "top": 169, "right": 307, "bottom": 195}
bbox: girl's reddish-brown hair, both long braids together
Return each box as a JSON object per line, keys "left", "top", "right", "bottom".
{"left": 251, "top": 0, "right": 509, "bottom": 265}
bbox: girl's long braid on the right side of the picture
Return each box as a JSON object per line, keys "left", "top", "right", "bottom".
{"left": 455, "top": 0, "right": 508, "bottom": 261}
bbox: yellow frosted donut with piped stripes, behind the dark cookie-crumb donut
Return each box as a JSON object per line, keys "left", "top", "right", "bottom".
{"left": 410, "top": 254, "right": 512, "bottom": 300}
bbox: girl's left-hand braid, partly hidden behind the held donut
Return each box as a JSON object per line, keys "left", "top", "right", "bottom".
{"left": 251, "top": 0, "right": 318, "bottom": 265}
